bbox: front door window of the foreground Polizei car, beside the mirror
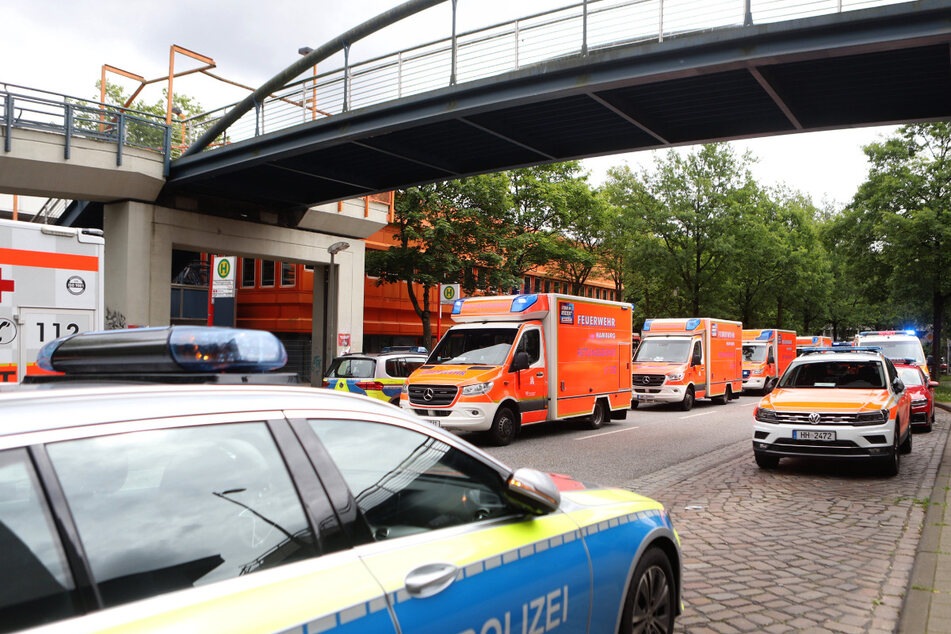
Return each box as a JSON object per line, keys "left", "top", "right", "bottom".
{"left": 309, "top": 420, "right": 512, "bottom": 539}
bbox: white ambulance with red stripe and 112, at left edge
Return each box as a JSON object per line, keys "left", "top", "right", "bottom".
{"left": 0, "top": 219, "right": 105, "bottom": 383}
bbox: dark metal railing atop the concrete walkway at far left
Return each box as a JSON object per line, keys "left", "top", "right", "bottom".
{"left": 0, "top": 83, "right": 172, "bottom": 175}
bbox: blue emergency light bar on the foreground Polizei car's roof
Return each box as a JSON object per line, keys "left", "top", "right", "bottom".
{"left": 36, "top": 326, "right": 287, "bottom": 375}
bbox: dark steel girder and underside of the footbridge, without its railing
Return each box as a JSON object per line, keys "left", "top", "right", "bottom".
{"left": 163, "top": 2, "right": 951, "bottom": 211}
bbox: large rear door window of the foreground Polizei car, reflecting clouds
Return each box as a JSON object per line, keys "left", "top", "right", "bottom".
{"left": 48, "top": 423, "right": 317, "bottom": 606}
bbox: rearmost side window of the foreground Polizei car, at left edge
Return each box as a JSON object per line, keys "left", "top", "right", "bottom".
{"left": 0, "top": 449, "right": 80, "bottom": 632}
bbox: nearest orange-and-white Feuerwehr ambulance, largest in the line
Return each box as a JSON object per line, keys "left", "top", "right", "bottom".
{"left": 400, "top": 293, "right": 632, "bottom": 445}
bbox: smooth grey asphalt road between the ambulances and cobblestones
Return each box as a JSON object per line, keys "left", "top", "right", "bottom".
{"left": 463, "top": 396, "right": 760, "bottom": 486}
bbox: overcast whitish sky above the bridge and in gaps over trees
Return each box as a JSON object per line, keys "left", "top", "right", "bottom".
{"left": 0, "top": 0, "right": 894, "bottom": 209}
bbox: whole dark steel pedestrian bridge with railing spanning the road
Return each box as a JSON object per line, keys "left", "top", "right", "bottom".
{"left": 162, "top": 0, "right": 951, "bottom": 210}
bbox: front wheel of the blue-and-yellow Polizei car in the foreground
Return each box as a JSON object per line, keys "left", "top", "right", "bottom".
{"left": 618, "top": 547, "right": 677, "bottom": 634}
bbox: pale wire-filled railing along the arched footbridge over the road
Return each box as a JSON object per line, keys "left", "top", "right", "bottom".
{"left": 185, "top": 0, "right": 909, "bottom": 147}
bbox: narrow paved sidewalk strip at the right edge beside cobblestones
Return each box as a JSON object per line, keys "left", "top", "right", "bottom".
{"left": 898, "top": 403, "right": 951, "bottom": 634}
